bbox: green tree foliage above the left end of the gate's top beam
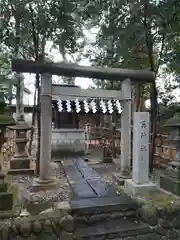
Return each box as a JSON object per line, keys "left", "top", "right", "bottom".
{"left": 0, "top": 0, "right": 85, "bottom": 58}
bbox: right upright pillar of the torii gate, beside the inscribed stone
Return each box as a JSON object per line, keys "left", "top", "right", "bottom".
{"left": 121, "top": 79, "right": 131, "bottom": 175}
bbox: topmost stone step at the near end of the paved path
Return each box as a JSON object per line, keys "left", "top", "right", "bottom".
{"left": 71, "top": 195, "right": 138, "bottom": 216}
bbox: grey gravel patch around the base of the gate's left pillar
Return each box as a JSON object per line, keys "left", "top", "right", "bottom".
{"left": 12, "top": 162, "right": 70, "bottom": 203}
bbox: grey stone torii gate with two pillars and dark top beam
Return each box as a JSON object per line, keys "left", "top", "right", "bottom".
{"left": 12, "top": 59, "right": 155, "bottom": 188}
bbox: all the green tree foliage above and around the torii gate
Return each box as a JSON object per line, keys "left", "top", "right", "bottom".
{"left": 0, "top": 0, "right": 180, "bottom": 108}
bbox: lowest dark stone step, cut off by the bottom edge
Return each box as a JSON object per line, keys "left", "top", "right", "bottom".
{"left": 75, "top": 217, "right": 151, "bottom": 240}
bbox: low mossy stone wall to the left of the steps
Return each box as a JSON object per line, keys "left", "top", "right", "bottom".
{"left": 0, "top": 203, "right": 74, "bottom": 240}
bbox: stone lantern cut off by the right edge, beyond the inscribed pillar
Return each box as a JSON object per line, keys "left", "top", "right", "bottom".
{"left": 160, "top": 113, "right": 180, "bottom": 196}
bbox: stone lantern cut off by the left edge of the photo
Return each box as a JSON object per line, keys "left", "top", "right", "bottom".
{"left": 0, "top": 102, "right": 15, "bottom": 218}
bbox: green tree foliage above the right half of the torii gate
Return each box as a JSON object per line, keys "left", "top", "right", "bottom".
{"left": 81, "top": 0, "right": 180, "bottom": 106}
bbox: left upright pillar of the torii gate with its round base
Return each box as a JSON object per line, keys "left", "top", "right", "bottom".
{"left": 33, "top": 74, "right": 58, "bottom": 190}
